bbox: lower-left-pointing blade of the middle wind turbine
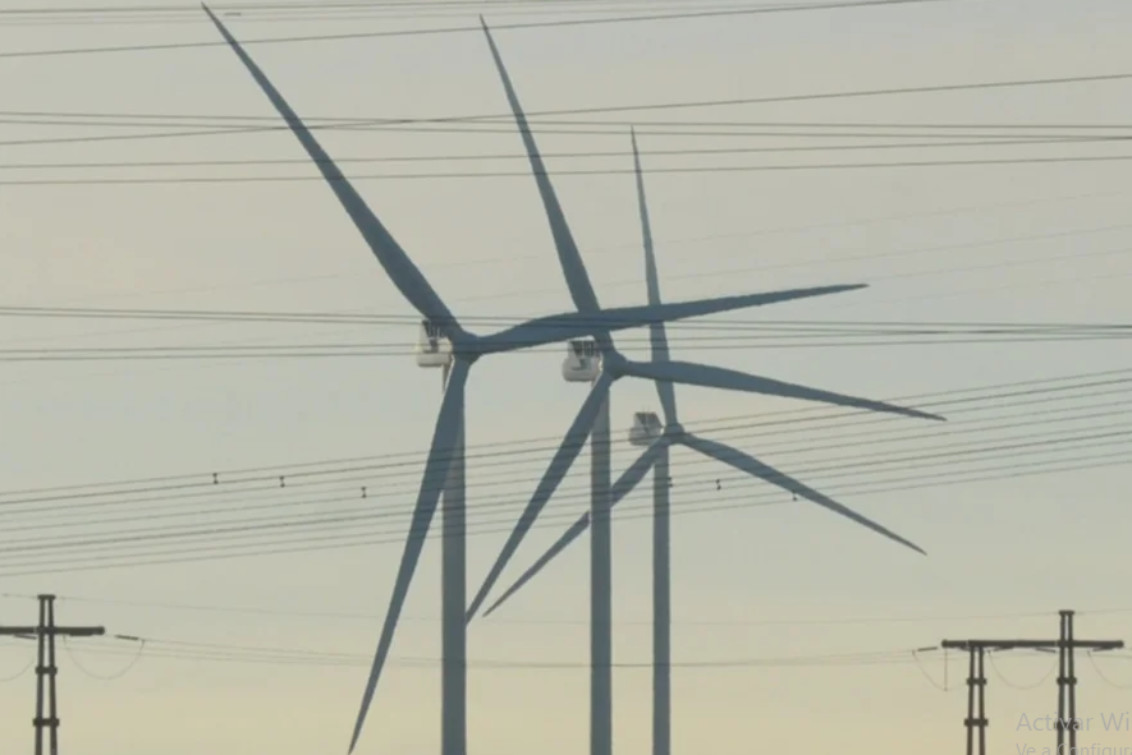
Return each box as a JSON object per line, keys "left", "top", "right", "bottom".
{"left": 468, "top": 372, "right": 614, "bottom": 621}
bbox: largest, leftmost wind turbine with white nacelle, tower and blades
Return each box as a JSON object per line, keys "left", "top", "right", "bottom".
{"left": 201, "top": 6, "right": 863, "bottom": 755}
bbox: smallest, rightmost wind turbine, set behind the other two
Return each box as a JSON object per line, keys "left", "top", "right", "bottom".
{"left": 484, "top": 135, "right": 937, "bottom": 755}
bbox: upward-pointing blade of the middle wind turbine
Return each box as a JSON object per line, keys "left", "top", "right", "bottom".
{"left": 480, "top": 16, "right": 599, "bottom": 337}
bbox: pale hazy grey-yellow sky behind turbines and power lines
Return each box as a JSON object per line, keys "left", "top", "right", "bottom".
{"left": 0, "top": 0, "right": 1132, "bottom": 755}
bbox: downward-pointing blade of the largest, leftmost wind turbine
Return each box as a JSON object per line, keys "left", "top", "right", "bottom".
{"left": 350, "top": 359, "right": 471, "bottom": 752}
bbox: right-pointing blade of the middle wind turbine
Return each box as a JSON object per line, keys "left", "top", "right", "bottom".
{"left": 621, "top": 362, "right": 943, "bottom": 421}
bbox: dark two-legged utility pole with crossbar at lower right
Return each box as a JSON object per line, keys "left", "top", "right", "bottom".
{"left": 940, "top": 610, "right": 1124, "bottom": 755}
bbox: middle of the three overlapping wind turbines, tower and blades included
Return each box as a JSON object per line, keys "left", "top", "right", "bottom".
{"left": 468, "top": 23, "right": 943, "bottom": 755}
